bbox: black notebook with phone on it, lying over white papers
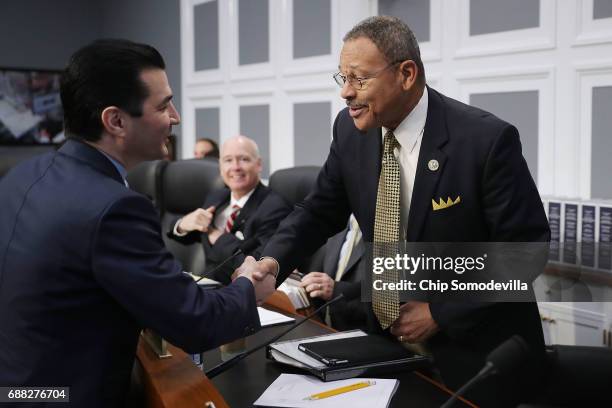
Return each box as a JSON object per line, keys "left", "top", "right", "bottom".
{"left": 298, "top": 335, "right": 414, "bottom": 367}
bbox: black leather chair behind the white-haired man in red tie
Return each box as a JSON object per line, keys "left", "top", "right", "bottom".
{"left": 161, "top": 159, "right": 223, "bottom": 274}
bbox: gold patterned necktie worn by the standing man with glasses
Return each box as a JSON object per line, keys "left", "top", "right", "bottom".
{"left": 372, "top": 131, "right": 400, "bottom": 329}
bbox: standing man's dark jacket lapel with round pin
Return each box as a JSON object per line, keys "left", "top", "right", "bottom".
{"left": 406, "top": 87, "right": 448, "bottom": 241}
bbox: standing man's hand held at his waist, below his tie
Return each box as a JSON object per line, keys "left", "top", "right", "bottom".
{"left": 391, "top": 302, "right": 440, "bottom": 343}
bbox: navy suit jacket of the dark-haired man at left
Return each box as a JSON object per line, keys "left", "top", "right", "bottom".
{"left": 0, "top": 140, "right": 259, "bottom": 407}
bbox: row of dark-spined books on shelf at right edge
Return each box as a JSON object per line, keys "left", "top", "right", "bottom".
{"left": 543, "top": 197, "right": 612, "bottom": 272}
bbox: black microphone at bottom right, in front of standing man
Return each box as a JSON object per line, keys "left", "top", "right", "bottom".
{"left": 440, "top": 334, "right": 530, "bottom": 408}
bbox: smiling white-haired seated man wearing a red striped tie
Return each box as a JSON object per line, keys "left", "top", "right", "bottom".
{"left": 168, "top": 135, "right": 291, "bottom": 284}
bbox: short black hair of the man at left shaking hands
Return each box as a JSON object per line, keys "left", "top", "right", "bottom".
{"left": 60, "top": 39, "right": 166, "bottom": 142}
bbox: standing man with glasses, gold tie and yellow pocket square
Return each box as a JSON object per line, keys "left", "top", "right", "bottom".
{"left": 244, "top": 16, "right": 550, "bottom": 405}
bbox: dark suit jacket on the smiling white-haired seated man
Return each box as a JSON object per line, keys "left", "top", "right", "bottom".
{"left": 168, "top": 183, "right": 291, "bottom": 284}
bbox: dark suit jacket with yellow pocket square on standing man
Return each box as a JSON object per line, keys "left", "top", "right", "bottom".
{"left": 262, "top": 88, "right": 550, "bottom": 401}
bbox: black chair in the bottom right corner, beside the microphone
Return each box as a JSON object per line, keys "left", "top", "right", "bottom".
{"left": 520, "top": 345, "right": 612, "bottom": 408}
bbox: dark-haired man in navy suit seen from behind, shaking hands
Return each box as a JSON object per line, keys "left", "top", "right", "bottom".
{"left": 0, "top": 40, "right": 274, "bottom": 407}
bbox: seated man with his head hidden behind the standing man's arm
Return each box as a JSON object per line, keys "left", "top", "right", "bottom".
{"left": 301, "top": 215, "right": 367, "bottom": 331}
